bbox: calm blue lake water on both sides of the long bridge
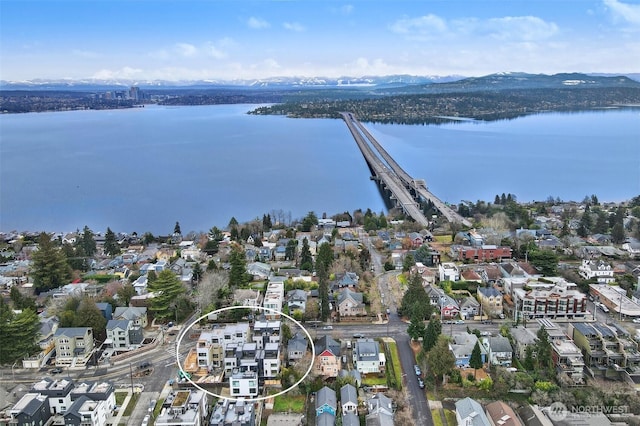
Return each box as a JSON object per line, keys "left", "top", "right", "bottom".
{"left": 0, "top": 105, "right": 640, "bottom": 234}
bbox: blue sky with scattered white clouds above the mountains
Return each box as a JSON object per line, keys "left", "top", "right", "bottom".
{"left": 0, "top": 0, "right": 640, "bottom": 81}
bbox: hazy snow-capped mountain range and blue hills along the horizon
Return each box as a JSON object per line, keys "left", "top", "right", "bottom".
{"left": 0, "top": 72, "right": 640, "bottom": 94}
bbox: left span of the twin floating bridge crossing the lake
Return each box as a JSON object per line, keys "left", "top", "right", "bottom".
{"left": 343, "top": 114, "right": 429, "bottom": 227}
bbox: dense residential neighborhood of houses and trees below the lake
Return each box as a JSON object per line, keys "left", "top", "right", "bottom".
{"left": 0, "top": 195, "right": 640, "bottom": 426}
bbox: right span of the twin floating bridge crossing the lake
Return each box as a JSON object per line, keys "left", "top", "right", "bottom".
{"left": 342, "top": 113, "right": 471, "bottom": 227}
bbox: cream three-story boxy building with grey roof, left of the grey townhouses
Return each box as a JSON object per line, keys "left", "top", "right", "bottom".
{"left": 54, "top": 327, "right": 95, "bottom": 367}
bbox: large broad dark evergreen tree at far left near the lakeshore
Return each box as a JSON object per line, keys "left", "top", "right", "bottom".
{"left": 31, "top": 232, "right": 71, "bottom": 294}
